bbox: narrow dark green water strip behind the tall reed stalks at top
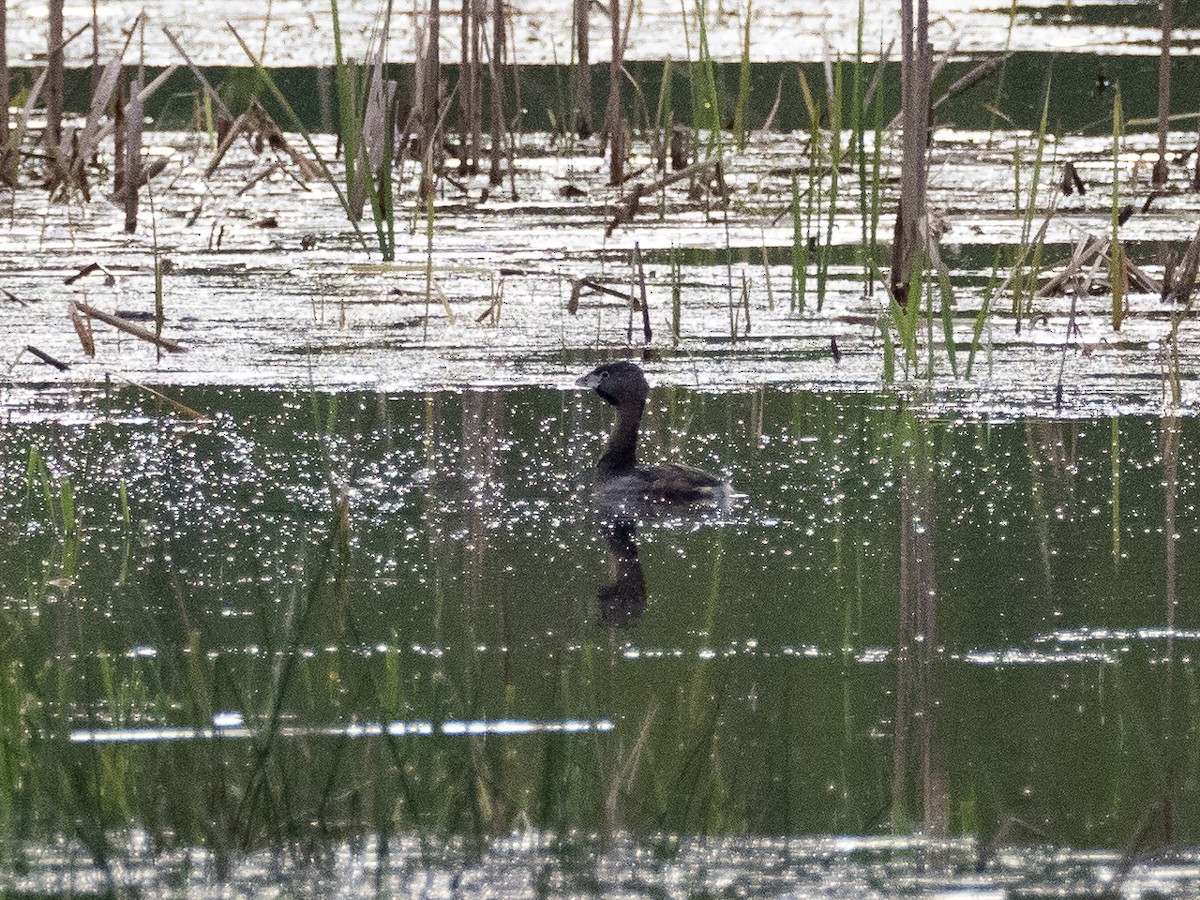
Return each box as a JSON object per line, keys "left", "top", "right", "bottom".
{"left": 12, "top": 50, "right": 1200, "bottom": 134}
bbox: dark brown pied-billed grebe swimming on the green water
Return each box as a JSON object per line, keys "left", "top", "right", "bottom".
{"left": 576, "top": 362, "right": 732, "bottom": 503}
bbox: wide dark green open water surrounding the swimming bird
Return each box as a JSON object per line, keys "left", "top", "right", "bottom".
{"left": 0, "top": 389, "right": 1200, "bottom": 859}
